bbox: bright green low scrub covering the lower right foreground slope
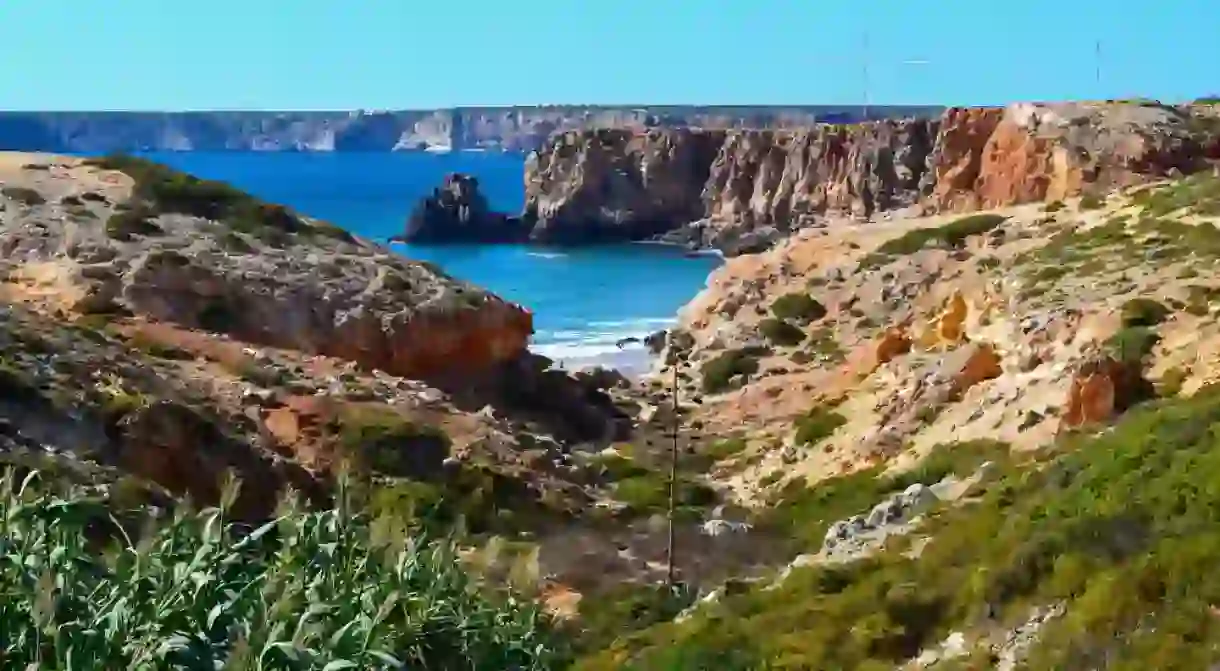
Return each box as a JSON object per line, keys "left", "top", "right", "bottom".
{"left": 577, "top": 388, "right": 1220, "bottom": 671}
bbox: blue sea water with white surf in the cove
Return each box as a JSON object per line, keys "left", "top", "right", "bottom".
{"left": 133, "top": 153, "right": 720, "bottom": 373}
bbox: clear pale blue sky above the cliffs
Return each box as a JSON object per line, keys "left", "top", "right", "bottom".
{"left": 0, "top": 0, "right": 1220, "bottom": 110}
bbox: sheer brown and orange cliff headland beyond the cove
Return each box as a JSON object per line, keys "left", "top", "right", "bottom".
{"left": 525, "top": 102, "right": 1220, "bottom": 253}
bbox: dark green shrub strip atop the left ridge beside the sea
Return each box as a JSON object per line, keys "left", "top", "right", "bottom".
{"left": 85, "top": 155, "right": 353, "bottom": 244}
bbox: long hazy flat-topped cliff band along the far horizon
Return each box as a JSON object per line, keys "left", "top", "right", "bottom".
{"left": 0, "top": 105, "right": 941, "bottom": 153}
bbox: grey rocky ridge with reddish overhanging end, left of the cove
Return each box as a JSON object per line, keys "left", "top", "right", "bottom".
{"left": 0, "top": 153, "right": 533, "bottom": 378}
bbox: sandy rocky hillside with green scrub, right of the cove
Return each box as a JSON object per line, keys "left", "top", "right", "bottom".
{"left": 566, "top": 165, "right": 1220, "bottom": 670}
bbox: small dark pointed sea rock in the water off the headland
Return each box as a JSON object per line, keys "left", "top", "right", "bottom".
{"left": 390, "top": 173, "right": 528, "bottom": 244}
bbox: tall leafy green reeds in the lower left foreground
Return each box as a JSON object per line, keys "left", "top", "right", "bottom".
{"left": 0, "top": 473, "right": 566, "bottom": 671}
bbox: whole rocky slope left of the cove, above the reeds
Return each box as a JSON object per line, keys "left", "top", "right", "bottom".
{"left": 0, "top": 154, "right": 649, "bottom": 531}
